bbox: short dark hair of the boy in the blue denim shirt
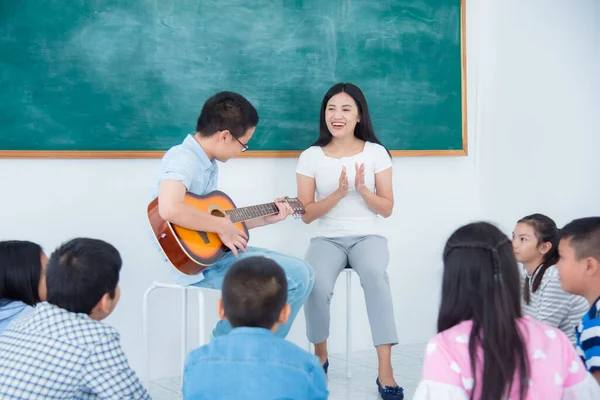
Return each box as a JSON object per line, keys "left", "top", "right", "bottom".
{"left": 221, "top": 256, "right": 287, "bottom": 329}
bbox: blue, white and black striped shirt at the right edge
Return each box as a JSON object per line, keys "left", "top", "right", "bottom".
{"left": 575, "top": 297, "right": 600, "bottom": 372}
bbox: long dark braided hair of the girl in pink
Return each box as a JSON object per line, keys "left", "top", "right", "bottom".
{"left": 438, "top": 222, "right": 529, "bottom": 400}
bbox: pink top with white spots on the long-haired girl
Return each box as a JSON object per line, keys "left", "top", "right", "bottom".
{"left": 415, "top": 317, "right": 600, "bottom": 400}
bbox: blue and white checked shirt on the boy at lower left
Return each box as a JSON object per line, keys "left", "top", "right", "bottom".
{"left": 0, "top": 303, "right": 150, "bottom": 399}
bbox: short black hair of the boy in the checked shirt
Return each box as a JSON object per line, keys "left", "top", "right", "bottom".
{"left": 46, "top": 238, "right": 122, "bottom": 315}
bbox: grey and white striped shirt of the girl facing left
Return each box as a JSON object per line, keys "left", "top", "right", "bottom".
{"left": 521, "top": 265, "right": 589, "bottom": 345}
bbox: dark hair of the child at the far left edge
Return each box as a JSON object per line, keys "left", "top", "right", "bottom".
{"left": 0, "top": 240, "right": 43, "bottom": 306}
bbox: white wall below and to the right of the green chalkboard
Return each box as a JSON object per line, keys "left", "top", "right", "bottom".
{"left": 0, "top": 0, "right": 600, "bottom": 382}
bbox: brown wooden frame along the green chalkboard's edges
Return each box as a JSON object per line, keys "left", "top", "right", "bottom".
{"left": 0, "top": 0, "right": 469, "bottom": 159}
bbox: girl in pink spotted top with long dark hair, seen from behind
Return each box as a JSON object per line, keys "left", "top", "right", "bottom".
{"left": 413, "top": 222, "right": 600, "bottom": 400}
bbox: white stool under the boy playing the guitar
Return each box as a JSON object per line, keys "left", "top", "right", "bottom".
{"left": 142, "top": 282, "right": 210, "bottom": 383}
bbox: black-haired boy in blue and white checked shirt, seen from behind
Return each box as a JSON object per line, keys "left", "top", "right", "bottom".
{"left": 0, "top": 238, "right": 150, "bottom": 400}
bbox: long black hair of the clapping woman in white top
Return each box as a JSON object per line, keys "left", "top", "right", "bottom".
{"left": 313, "top": 83, "right": 390, "bottom": 154}
